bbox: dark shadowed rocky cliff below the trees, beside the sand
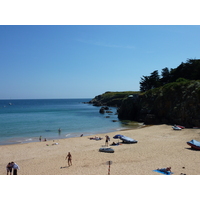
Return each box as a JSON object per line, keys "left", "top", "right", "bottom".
{"left": 118, "top": 80, "right": 200, "bottom": 127}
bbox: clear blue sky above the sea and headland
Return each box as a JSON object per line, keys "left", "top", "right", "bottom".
{"left": 0, "top": 25, "right": 200, "bottom": 99}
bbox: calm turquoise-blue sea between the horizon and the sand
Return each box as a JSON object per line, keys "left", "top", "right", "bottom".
{"left": 0, "top": 98, "right": 139, "bottom": 145}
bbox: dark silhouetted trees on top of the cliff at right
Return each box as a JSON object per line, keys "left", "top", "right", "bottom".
{"left": 140, "top": 59, "right": 200, "bottom": 92}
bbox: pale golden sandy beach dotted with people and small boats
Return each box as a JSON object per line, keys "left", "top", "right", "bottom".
{"left": 0, "top": 125, "right": 200, "bottom": 175}
